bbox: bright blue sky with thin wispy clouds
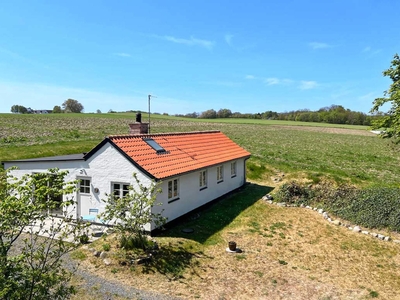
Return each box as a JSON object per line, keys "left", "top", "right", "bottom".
{"left": 0, "top": 0, "right": 400, "bottom": 114}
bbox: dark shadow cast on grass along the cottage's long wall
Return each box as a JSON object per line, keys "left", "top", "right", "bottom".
{"left": 158, "top": 183, "right": 273, "bottom": 244}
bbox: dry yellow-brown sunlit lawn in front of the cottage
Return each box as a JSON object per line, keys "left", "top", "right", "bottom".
{"left": 73, "top": 193, "right": 400, "bottom": 299}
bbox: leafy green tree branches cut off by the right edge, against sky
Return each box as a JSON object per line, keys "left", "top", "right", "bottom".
{"left": 370, "top": 53, "right": 400, "bottom": 143}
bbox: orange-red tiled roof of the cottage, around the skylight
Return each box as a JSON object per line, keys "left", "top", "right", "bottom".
{"left": 108, "top": 131, "right": 250, "bottom": 179}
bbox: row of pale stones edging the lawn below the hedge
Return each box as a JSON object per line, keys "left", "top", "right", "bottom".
{"left": 262, "top": 194, "right": 400, "bottom": 244}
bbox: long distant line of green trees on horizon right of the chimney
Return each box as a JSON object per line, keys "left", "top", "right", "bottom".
{"left": 176, "top": 105, "right": 376, "bottom": 125}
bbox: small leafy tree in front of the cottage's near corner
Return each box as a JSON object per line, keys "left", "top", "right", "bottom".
{"left": 100, "top": 174, "right": 166, "bottom": 249}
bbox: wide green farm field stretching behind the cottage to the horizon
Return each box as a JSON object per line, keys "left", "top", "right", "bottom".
{"left": 0, "top": 113, "right": 400, "bottom": 186}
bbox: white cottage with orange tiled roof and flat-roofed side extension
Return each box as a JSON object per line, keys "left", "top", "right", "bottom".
{"left": 3, "top": 131, "right": 250, "bottom": 229}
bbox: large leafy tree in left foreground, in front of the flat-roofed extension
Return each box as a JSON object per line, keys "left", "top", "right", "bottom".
{"left": 0, "top": 169, "right": 85, "bottom": 299}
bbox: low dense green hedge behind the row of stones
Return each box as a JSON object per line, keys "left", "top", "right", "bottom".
{"left": 275, "top": 182, "right": 400, "bottom": 231}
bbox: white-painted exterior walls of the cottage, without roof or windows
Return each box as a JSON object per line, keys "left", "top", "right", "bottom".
{"left": 4, "top": 143, "right": 245, "bottom": 230}
